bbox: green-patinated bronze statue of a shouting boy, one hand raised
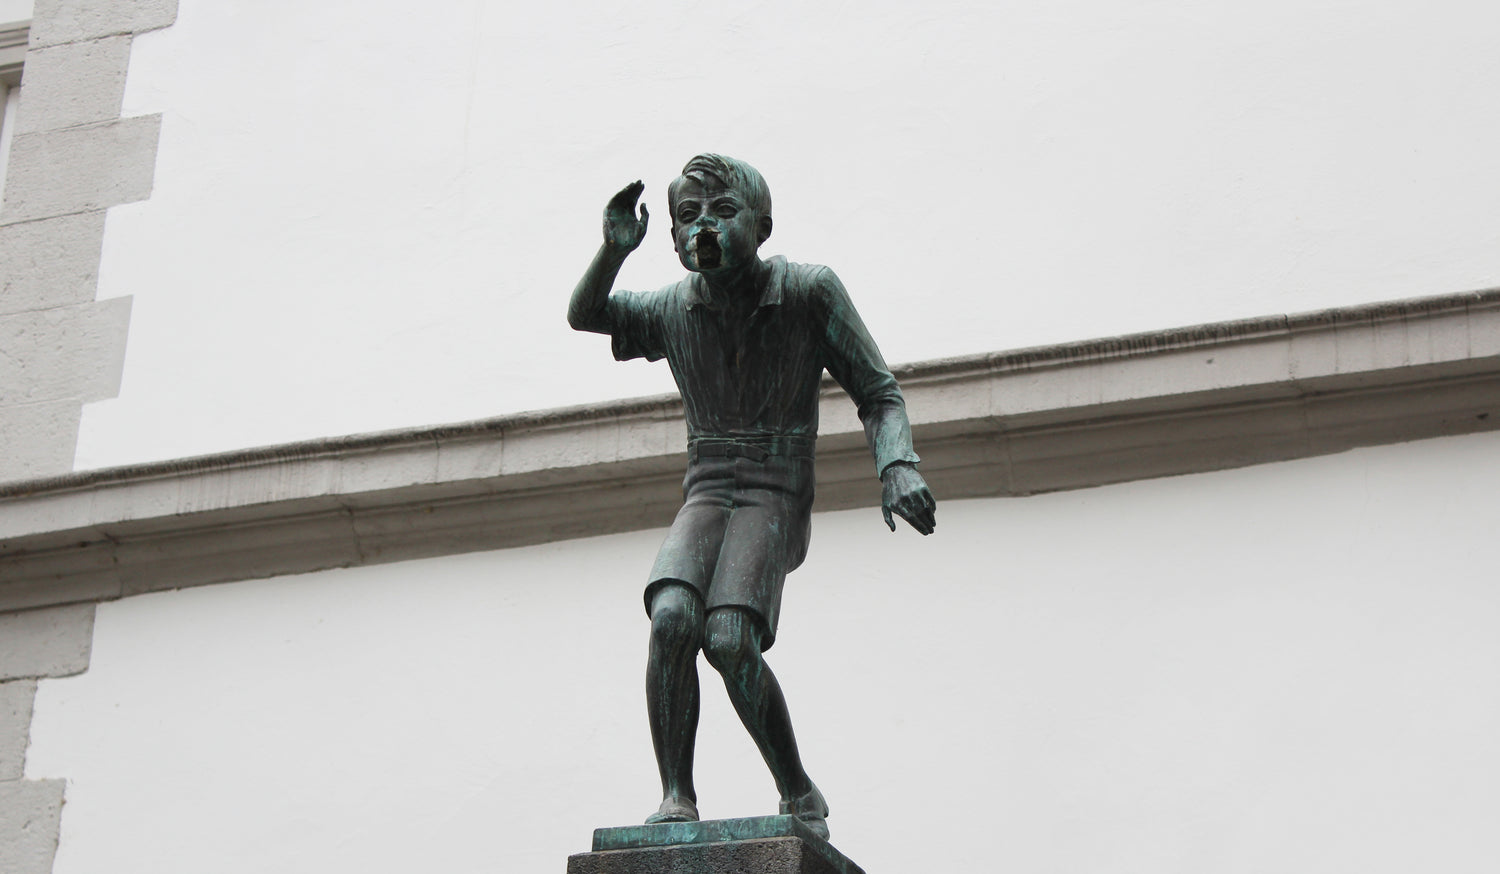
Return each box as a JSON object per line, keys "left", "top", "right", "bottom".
{"left": 569, "top": 154, "right": 936, "bottom": 837}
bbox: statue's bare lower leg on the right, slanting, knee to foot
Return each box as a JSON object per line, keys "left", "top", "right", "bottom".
{"left": 704, "top": 607, "right": 828, "bottom": 837}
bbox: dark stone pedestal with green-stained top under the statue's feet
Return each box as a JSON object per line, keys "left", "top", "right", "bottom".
{"left": 567, "top": 816, "right": 864, "bottom": 874}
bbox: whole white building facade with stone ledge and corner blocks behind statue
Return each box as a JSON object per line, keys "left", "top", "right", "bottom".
{"left": 0, "top": 0, "right": 1500, "bottom": 874}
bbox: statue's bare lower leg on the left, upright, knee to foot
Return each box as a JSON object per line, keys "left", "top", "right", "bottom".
{"left": 647, "top": 583, "right": 704, "bottom": 823}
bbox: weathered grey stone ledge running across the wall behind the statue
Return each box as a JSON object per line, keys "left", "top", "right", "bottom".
{"left": 0, "top": 289, "right": 1500, "bottom": 610}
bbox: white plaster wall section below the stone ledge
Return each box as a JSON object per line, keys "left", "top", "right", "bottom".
{"left": 29, "top": 433, "right": 1500, "bottom": 874}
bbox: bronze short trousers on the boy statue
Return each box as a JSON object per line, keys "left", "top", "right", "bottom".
{"left": 645, "top": 436, "right": 813, "bottom": 649}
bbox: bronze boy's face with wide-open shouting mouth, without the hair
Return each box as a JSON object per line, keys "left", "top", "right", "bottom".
{"left": 672, "top": 175, "right": 770, "bottom": 274}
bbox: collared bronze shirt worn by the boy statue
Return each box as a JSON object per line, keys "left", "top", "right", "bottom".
{"left": 605, "top": 256, "right": 918, "bottom": 474}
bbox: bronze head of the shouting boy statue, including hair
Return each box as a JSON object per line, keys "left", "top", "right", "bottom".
{"left": 666, "top": 154, "right": 771, "bottom": 273}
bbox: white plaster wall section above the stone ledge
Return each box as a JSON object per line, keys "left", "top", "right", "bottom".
{"left": 78, "top": 0, "right": 1500, "bottom": 468}
